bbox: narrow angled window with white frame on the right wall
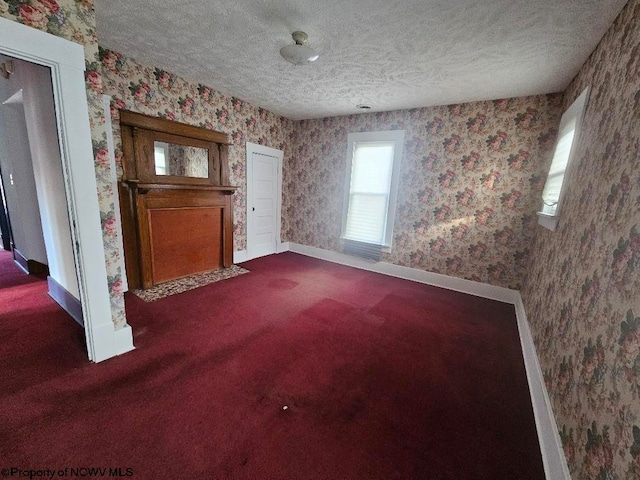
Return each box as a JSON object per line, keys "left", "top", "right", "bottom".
{"left": 538, "top": 87, "right": 589, "bottom": 230}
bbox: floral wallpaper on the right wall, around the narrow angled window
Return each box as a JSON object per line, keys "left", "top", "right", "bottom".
{"left": 522, "top": 0, "right": 640, "bottom": 480}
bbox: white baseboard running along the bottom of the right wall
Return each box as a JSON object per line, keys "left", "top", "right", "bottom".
{"left": 515, "top": 293, "right": 571, "bottom": 480}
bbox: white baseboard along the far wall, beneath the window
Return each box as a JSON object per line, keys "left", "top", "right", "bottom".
{"left": 289, "top": 243, "right": 520, "bottom": 304}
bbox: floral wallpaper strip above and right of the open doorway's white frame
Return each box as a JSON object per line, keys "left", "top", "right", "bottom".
{"left": 0, "top": 0, "right": 130, "bottom": 328}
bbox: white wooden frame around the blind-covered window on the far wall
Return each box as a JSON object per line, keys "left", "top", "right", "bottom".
{"left": 340, "top": 130, "right": 404, "bottom": 252}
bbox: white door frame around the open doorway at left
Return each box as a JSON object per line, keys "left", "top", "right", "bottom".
{"left": 0, "top": 18, "right": 133, "bottom": 362}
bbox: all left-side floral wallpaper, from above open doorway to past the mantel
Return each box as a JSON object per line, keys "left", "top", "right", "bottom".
{"left": 0, "top": 0, "right": 292, "bottom": 327}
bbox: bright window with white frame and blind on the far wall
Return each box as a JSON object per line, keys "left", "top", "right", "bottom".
{"left": 342, "top": 130, "right": 404, "bottom": 256}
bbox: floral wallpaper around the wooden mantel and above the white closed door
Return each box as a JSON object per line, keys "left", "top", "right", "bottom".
{"left": 98, "top": 47, "right": 294, "bottom": 255}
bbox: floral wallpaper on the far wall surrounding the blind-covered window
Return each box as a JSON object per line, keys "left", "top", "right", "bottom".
{"left": 283, "top": 95, "right": 562, "bottom": 289}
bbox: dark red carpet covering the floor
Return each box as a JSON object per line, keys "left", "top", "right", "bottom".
{"left": 0, "top": 249, "right": 544, "bottom": 480}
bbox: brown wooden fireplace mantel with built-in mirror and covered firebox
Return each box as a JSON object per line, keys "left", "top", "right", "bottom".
{"left": 119, "top": 110, "right": 236, "bottom": 289}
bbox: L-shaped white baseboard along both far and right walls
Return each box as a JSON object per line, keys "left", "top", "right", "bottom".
{"left": 288, "top": 243, "right": 571, "bottom": 480}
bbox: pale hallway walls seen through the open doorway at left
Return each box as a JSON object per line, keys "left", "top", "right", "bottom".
{"left": 0, "top": 55, "right": 84, "bottom": 325}
